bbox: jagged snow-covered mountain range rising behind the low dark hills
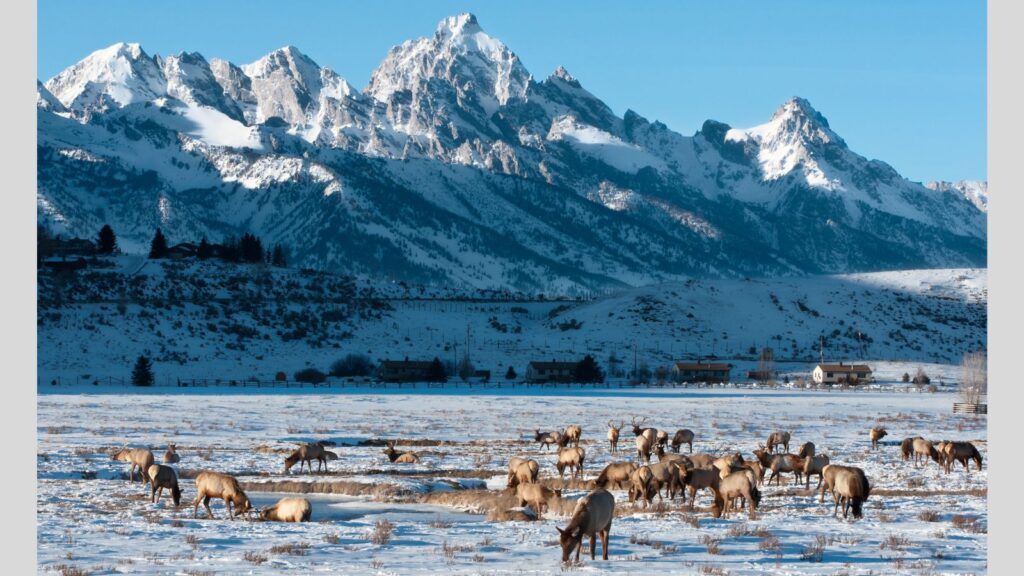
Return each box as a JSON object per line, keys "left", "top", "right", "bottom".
{"left": 37, "top": 14, "right": 987, "bottom": 292}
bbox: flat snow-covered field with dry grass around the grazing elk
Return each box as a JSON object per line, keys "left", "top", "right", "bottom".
{"left": 37, "top": 388, "right": 988, "bottom": 574}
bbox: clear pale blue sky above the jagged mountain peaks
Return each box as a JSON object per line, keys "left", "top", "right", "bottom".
{"left": 38, "top": 0, "right": 986, "bottom": 181}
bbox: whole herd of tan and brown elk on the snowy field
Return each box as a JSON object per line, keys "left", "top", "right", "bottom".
{"left": 101, "top": 417, "right": 982, "bottom": 561}
